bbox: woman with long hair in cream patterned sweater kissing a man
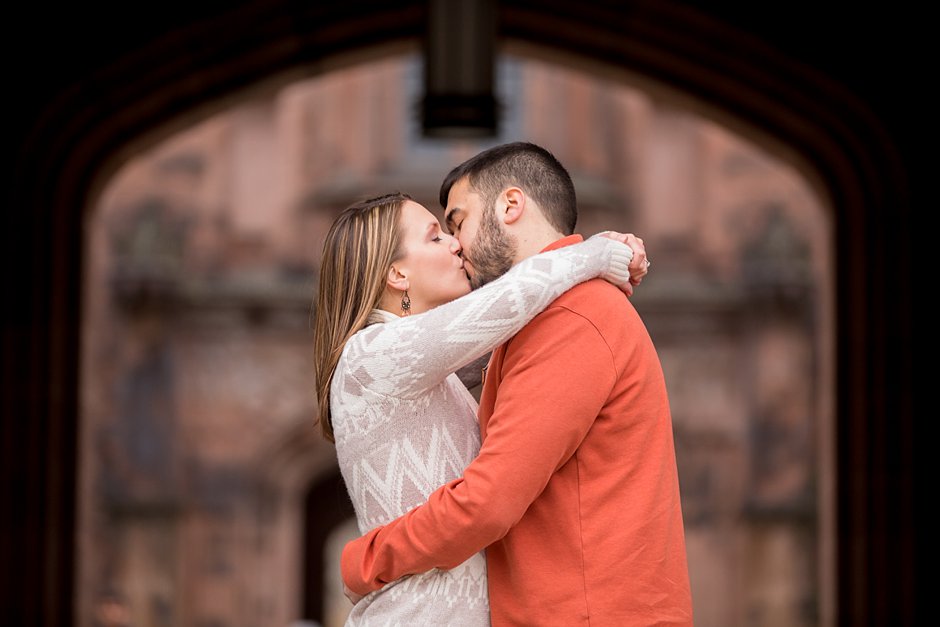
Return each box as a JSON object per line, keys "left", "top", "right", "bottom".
{"left": 315, "top": 194, "right": 632, "bottom": 625}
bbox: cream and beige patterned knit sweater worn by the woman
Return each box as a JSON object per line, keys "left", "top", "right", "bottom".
{"left": 330, "top": 237, "right": 632, "bottom": 627}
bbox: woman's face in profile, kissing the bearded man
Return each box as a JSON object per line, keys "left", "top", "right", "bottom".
{"left": 393, "top": 200, "right": 470, "bottom": 313}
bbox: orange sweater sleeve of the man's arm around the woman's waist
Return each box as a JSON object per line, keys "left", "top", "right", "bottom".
{"left": 341, "top": 306, "right": 616, "bottom": 594}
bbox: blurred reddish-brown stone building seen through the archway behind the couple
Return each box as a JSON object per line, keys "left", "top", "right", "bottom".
{"left": 78, "top": 53, "right": 834, "bottom": 627}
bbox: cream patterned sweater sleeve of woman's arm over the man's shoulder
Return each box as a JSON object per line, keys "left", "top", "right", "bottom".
{"left": 338, "top": 237, "right": 633, "bottom": 398}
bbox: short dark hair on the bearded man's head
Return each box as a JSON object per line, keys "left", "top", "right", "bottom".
{"left": 440, "top": 142, "right": 578, "bottom": 235}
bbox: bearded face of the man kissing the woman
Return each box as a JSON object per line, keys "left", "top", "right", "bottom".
{"left": 444, "top": 177, "right": 517, "bottom": 289}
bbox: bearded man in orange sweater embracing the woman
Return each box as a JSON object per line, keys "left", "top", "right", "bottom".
{"left": 342, "top": 143, "right": 692, "bottom": 627}
